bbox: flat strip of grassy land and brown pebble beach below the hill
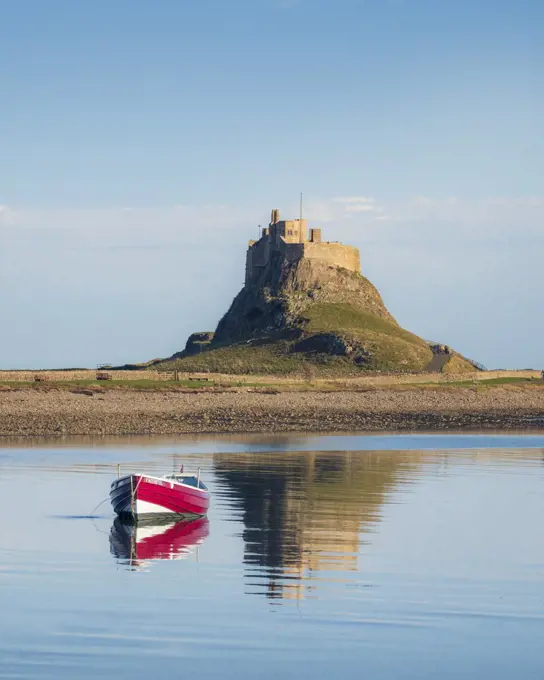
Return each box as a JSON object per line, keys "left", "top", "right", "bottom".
{"left": 0, "top": 371, "right": 544, "bottom": 437}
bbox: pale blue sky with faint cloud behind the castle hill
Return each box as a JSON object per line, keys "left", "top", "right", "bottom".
{"left": 0, "top": 0, "right": 544, "bottom": 368}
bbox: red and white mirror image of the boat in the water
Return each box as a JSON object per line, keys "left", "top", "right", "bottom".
{"left": 110, "top": 517, "right": 209, "bottom": 566}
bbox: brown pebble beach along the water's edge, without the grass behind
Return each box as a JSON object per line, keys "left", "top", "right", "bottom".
{"left": 0, "top": 386, "right": 544, "bottom": 437}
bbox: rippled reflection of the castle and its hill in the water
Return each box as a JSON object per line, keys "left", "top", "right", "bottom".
{"left": 214, "top": 452, "right": 415, "bottom": 599}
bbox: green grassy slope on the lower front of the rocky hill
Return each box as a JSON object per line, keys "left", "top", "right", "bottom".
{"left": 157, "top": 303, "right": 438, "bottom": 375}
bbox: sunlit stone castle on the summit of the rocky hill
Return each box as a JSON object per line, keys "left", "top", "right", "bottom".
{"left": 245, "top": 209, "right": 361, "bottom": 287}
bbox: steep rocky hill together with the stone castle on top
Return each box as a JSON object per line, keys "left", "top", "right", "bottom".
{"left": 155, "top": 212, "right": 475, "bottom": 375}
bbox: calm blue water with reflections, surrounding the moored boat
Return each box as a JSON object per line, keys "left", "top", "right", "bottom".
{"left": 0, "top": 435, "right": 544, "bottom": 680}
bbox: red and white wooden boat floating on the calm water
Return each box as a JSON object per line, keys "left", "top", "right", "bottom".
{"left": 110, "top": 471, "right": 210, "bottom": 520}
